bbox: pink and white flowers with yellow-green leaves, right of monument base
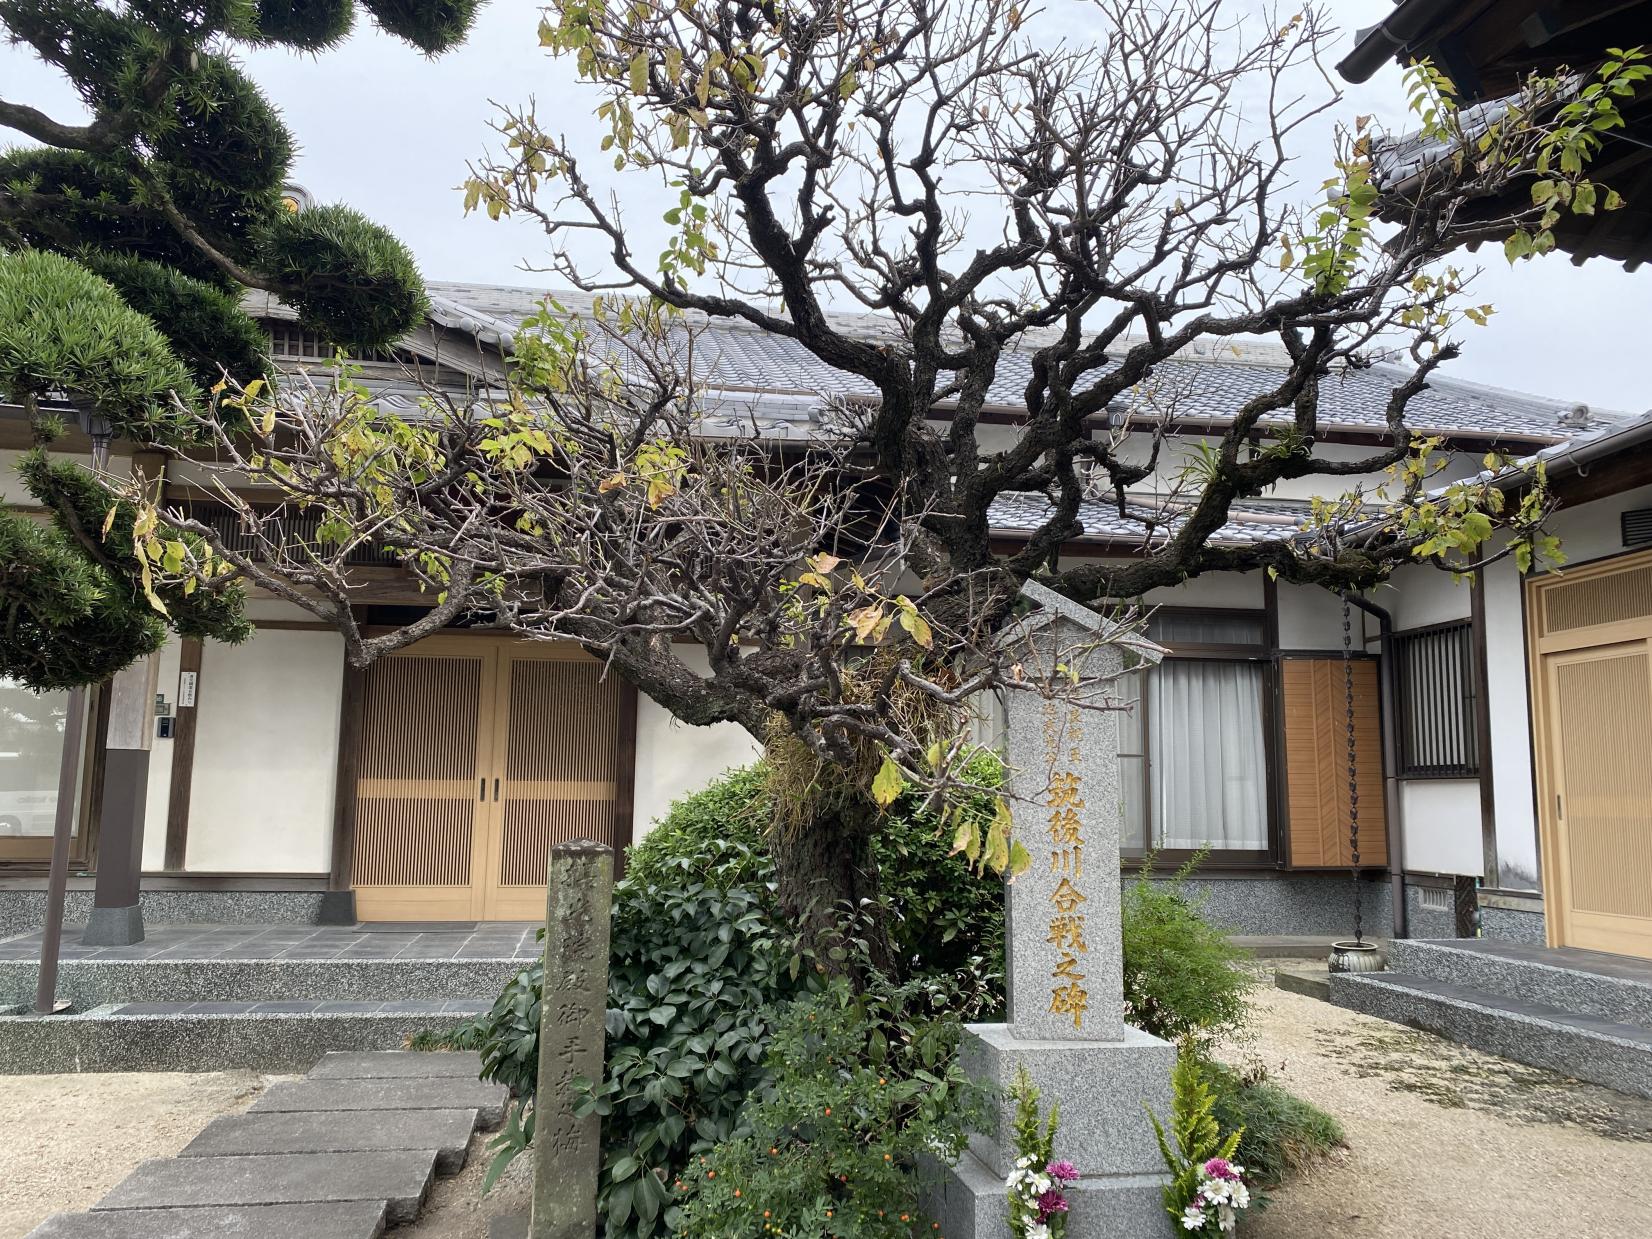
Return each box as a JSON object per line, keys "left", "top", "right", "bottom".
{"left": 1148, "top": 1047, "right": 1251, "bottom": 1236}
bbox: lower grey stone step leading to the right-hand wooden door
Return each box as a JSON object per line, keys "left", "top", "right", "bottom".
{"left": 1330, "top": 973, "right": 1652, "bottom": 1097}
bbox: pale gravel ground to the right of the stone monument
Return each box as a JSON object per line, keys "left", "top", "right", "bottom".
{"left": 1226, "top": 965, "right": 1652, "bottom": 1239}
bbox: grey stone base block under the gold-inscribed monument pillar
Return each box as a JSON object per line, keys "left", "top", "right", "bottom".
{"left": 927, "top": 1024, "right": 1176, "bottom": 1239}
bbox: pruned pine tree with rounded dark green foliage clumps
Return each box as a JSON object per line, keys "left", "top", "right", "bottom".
{"left": 0, "top": 0, "right": 481, "bottom": 689}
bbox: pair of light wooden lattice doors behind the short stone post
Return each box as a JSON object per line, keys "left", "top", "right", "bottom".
{"left": 352, "top": 634, "right": 628, "bottom": 920}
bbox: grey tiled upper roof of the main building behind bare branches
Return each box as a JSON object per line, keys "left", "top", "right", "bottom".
{"left": 419, "top": 282, "right": 1614, "bottom": 443}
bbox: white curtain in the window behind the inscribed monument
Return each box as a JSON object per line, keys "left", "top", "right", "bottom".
{"left": 1146, "top": 659, "right": 1267, "bottom": 851}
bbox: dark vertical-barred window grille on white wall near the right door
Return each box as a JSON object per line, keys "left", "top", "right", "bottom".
{"left": 1394, "top": 620, "right": 1480, "bottom": 778}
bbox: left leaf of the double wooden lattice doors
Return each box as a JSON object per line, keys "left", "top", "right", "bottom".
{"left": 352, "top": 638, "right": 497, "bottom": 920}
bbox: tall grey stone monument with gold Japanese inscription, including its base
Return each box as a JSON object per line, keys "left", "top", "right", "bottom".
{"left": 930, "top": 583, "right": 1176, "bottom": 1239}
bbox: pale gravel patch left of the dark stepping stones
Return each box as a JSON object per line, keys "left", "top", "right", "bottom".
{"left": 0, "top": 1070, "right": 276, "bottom": 1239}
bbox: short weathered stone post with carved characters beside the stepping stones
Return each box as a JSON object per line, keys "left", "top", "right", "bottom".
{"left": 527, "top": 839, "right": 613, "bottom": 1239}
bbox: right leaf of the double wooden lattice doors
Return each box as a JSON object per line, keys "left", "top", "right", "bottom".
{"left": 484, "top": 644, "right": 623, "bottom": 920}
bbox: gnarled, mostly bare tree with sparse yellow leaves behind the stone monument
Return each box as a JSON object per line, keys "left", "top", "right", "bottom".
{"left": 80, "top": 0, "right": 1640, "bottom": 938}
